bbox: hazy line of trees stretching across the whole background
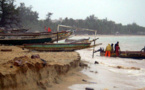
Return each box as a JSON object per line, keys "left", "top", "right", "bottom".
{"left": 0, "top": 0, "right": 145, "bottom": 35}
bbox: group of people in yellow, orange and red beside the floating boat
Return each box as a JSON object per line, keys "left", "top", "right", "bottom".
{"left": 105, "top": 42, "right": 120, "bottom": 57}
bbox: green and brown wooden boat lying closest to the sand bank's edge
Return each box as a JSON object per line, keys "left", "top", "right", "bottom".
{"left": 22, "top": 43, "right": 100, "bottom": 51}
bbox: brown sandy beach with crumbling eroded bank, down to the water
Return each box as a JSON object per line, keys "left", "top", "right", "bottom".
{"left": 0, "top": 46, "right": 87, "bottom": 90}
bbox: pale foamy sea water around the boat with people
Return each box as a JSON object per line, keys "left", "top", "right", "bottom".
{"left": 68, "top": 36, "right": 145, "bottom": 90}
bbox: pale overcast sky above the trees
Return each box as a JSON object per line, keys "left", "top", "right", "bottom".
{"left": 15, "top": 0, "right": 145, "bottom": 27}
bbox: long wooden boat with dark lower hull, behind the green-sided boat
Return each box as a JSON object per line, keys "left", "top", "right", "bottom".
{"left": 0, "top": 31, "right": 72, "bottom": 45}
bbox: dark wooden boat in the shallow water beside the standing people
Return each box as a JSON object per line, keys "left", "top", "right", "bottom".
{"left": 100, "top": 51, "right": 145, "bottom": 59}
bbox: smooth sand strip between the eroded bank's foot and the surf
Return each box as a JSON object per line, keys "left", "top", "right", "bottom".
{"left": 48, "top": 69, "right": 89, "bottom": 90}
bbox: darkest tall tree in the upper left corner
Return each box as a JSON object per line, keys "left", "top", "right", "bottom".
{"left": 0, "top": 0, "right": 20, "bottom": 28}
